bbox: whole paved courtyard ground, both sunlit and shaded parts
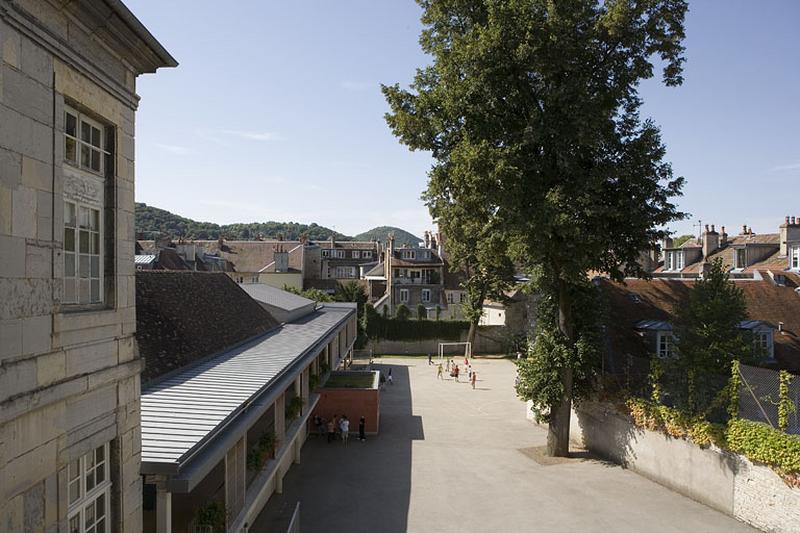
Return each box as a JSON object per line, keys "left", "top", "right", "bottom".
{"left": 251, "top": 358, "right": 755, "bottom": 533}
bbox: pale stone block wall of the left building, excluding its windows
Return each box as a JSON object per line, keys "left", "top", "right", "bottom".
{"left": 0, "top": 0, "right": 170, "bottom": 532}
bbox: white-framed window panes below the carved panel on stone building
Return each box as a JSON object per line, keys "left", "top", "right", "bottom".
{"left": 63, "top": 201, "right": 103, "bottom": 304}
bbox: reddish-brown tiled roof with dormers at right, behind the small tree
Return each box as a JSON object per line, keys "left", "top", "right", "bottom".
{"left": 601, "top": 278, "right": 800, "bottom": 373}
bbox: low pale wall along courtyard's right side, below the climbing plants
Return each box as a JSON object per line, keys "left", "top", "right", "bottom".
{"left": 528, "top": 403, "right": 800, "bottom": 533}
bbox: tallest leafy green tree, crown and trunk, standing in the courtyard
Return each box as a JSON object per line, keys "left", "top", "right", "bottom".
{"left": 383, "top": 0, "right": 687, "bottom": 456}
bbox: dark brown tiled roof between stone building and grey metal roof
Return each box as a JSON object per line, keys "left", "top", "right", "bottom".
{"left": 136, "top": 270, "right": 278, "bottom": 382}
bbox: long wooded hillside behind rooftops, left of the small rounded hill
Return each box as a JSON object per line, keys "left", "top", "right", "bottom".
{"left": 136, "top": 202, "right": 350, "bottom": 240}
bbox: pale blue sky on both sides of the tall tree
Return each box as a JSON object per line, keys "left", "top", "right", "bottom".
{"left": 126, "top": 0, "right": 800, "bottom": 235}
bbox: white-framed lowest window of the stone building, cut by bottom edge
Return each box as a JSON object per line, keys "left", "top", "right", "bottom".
{"left": 67, "top": 444, "right": 111, "bottom": 533}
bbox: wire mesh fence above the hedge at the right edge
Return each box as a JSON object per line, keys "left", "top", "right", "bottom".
{"left": 739, "top": 365, "right": 800, "bottom": 435}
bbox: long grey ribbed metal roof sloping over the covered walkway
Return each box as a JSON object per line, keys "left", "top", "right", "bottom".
{"left": 141, "top": 306, "right": 355, "bottom": 464}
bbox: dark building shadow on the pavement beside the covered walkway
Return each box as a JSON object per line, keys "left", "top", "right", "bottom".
{"left": 250, "top": 364, "right": 425, "bottom": 533}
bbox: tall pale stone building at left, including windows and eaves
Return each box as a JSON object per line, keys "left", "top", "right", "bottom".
{"left": 0, "top": 0, "right": 177, "bottom": 532}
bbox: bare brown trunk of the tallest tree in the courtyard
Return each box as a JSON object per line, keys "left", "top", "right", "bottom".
{"left": 547, "top": 280, "right": 575, "bottom": 457}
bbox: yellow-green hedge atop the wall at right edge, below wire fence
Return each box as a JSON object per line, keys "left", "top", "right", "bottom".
{"left": 727, "top": 419, "right": 800, "bottom": 475}
